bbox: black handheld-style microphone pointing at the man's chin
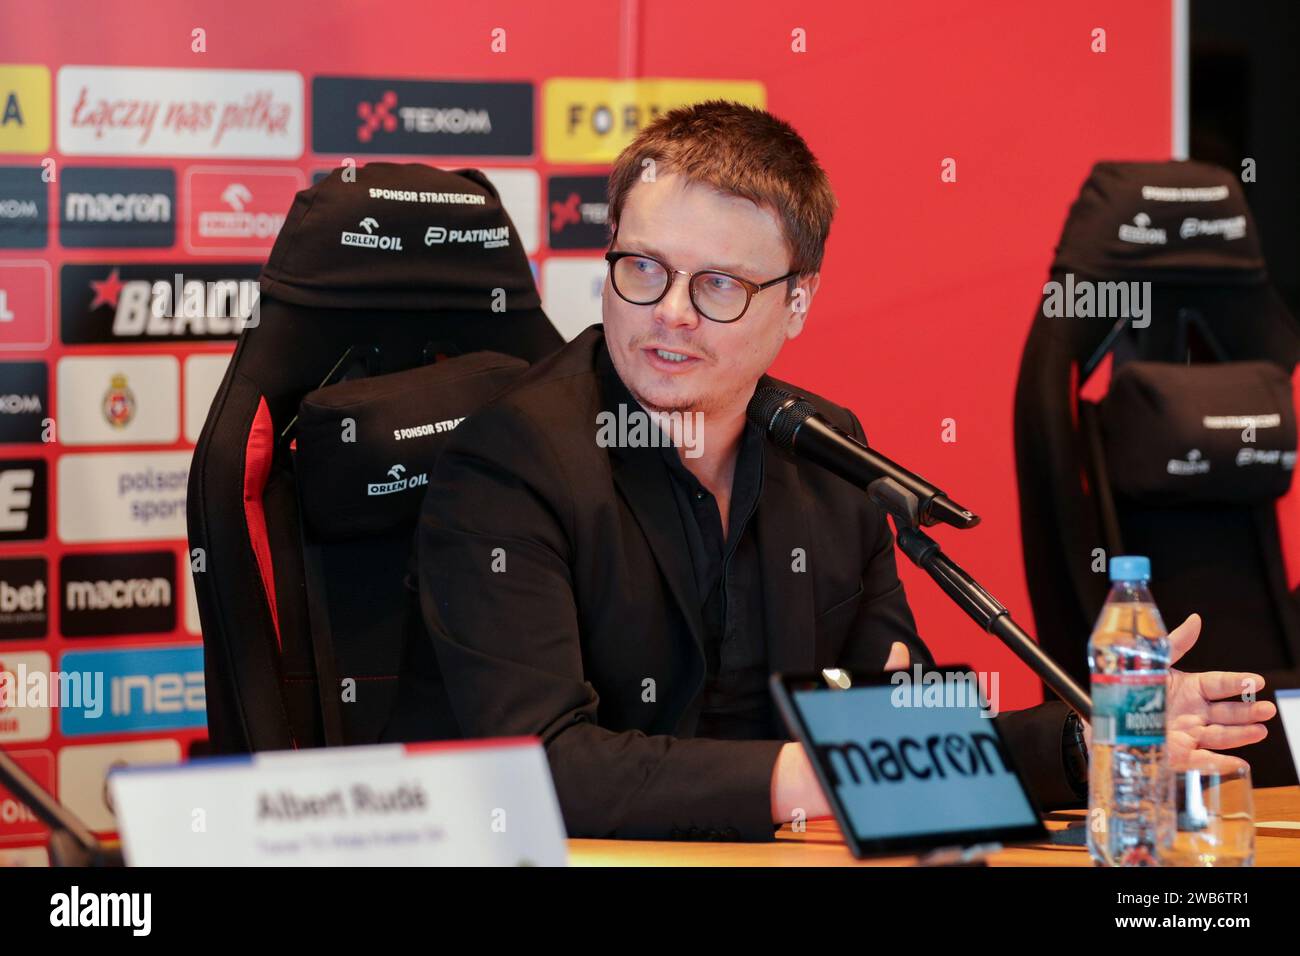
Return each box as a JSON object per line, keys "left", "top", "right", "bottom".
{"left": 745, "top": 385, "right": 979, "bottom": 529}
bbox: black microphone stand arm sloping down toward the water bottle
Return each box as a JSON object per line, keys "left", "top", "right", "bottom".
{"left": 867, "top": 477, "right": 1092, "bottom": 721}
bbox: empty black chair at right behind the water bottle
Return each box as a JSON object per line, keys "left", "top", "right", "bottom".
{"left": 1015, "top": 163, "right": 1300, "bottom": 784}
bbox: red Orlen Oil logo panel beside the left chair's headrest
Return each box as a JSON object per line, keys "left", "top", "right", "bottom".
{"left": 185, "top": 166, "right": 304, "bottom": 256}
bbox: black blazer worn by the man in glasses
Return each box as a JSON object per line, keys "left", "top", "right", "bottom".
{"left": 387, "top": 325, "right": 1078, "bottom": 839}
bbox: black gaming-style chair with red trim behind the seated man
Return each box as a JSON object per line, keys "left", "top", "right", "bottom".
{"left": 189, "top": 163, "right": 563, "bottom": 753}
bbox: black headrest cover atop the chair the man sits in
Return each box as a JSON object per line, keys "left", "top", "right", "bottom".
{"left": 261, "top": 163, "right": 541, "bottom": 315}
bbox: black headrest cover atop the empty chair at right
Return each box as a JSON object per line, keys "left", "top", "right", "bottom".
{"left": 1052, "top": 161, "right": 1268, "bottom": 284}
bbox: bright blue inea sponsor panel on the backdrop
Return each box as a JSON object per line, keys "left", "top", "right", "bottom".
{"left": 59, "top": 644, "right": 207, "bottom": 736}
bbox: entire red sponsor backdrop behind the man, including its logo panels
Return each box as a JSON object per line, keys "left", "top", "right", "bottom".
{"left": 0, "top": 0, "right": 1237, "bottom": 861}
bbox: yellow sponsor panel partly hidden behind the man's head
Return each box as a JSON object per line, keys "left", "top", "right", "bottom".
{"left": 542, "top": 78, "right": 767, "bottom": 164}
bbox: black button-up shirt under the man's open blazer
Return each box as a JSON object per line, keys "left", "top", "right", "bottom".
{"left": 662, "top": 424, "right": 785, "bottom": 740}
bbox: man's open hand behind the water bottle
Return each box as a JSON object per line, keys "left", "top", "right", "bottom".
{"left": 1083, "top": 614, "right": 1278, "bottom": 773}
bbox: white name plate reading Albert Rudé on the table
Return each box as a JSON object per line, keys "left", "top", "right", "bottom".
{"left": 108, "top": 737, "right": 568, "bottom": 866}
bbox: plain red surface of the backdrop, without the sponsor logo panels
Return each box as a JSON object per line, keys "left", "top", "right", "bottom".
{"left": 0, "top": 0, "right": 1171, "bottom": 858}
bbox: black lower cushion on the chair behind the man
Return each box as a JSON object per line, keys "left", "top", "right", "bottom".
{"left": 295, "top": 351, "right": 528, "bottom": 541}
